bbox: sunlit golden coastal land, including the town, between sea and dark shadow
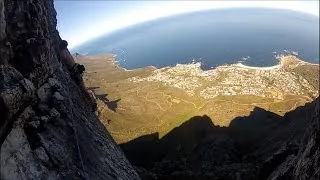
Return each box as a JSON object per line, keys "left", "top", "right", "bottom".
{"left": 75, "top": 54, "right": 319, "bottom": 143}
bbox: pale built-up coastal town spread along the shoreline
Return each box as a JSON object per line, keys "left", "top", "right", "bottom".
{"left": 128, "top": 56, "right": 319, "bottom": 100}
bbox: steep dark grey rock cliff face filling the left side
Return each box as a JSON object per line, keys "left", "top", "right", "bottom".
{"left": 0, "top": 0, "right": 139, "bottom": 180}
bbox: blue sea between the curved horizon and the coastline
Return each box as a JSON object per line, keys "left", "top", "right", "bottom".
{"left": 72, "top": 8, "right": 319, "bottom": 69}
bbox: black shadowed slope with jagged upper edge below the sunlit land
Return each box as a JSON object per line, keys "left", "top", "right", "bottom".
{"left": 120, "top": 98, "right": 319, "bottom": 180}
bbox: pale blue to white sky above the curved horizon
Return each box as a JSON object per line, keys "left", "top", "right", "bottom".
{"left": 54, "top": 0, "right": 319, "bottom": 48}
